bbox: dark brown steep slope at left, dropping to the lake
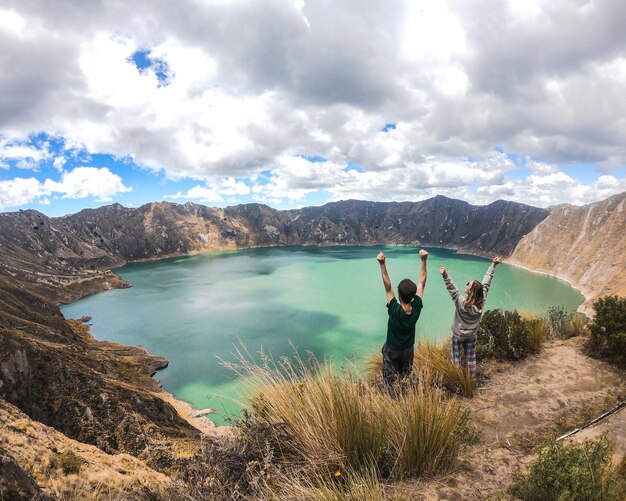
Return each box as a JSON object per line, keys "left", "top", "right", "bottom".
{"left": 0, "top": 278, "right": 199, "bottom": 466}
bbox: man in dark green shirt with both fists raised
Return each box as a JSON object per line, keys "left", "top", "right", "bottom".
{"left": 376, "top": 249, "right": 428, "bottom": 385}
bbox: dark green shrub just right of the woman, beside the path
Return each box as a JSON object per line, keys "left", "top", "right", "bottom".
{"left": 476, "top": 310, "right": 530, "bottom": 360}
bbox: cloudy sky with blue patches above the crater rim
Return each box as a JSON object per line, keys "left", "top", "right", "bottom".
{"left": 0, "top": 0, "right": 626, "bottom": 216}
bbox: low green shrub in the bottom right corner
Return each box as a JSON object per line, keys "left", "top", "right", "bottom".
{"left": 511, "top": 436, "right": 626, "bottom": 501}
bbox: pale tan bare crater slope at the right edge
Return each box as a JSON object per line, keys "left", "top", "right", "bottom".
{"left": 509, "top": 193, "right": 626, "bottom": 313}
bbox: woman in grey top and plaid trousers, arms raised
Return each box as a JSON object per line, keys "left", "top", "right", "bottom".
{"left": 439, "top": 256, "right": 500, "bottom": 377}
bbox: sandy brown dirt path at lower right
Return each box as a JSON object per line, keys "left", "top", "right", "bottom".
{"left": 402, "top": 338, "right": 626, "bottom": 500}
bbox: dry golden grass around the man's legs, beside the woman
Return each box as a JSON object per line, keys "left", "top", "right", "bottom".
{"left": 364, "top": 341, "right": 475, "bottom": 398}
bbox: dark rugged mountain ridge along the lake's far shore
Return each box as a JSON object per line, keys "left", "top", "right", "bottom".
{"left": 0, "top": 196, "right": 548, "bottom": 302}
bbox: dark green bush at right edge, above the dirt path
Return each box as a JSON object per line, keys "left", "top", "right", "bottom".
{"left": 587, "top": 296, "right": 626, "bottom": 366}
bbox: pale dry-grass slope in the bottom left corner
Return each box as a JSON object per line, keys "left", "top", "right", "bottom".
{"left": 0, "top": 399, "right": 176, "bottom": 501}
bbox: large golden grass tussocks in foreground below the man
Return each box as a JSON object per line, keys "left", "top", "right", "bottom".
{"left": 222, "top": 346, "right": 470, "bottom": 499}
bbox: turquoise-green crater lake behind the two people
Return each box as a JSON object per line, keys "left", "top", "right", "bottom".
{"left": 62, "top": 247, "right": 584, "bottom": 424}
